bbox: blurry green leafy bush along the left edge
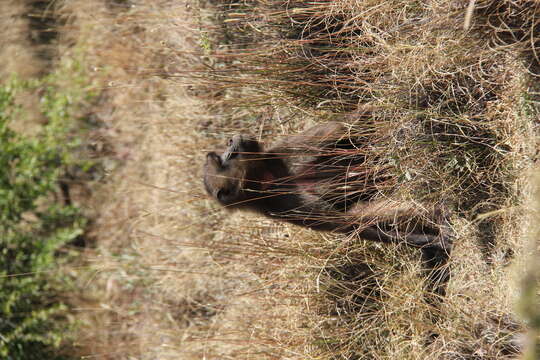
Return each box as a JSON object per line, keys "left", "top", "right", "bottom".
{"left": 0, "top": 80, "right": 85, "bottom": 359}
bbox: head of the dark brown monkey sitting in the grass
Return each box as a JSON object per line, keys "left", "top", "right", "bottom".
{"left": 204, "top": 135, "right": 261, "bottom": 206}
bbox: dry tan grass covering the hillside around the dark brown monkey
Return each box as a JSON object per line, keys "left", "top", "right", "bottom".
{"left": 0, "top": 0, "right": 540, "bottom": 359}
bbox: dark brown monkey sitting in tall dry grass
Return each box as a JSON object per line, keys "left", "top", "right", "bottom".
{"left": 204, "top": 122, "right": 452, "bottom": 294}
